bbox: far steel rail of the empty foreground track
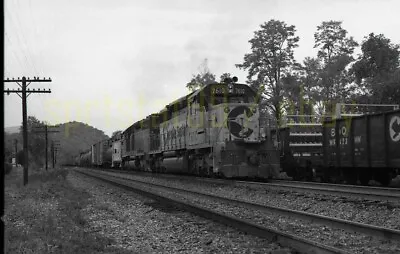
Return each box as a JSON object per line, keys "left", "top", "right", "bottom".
{"left": 79, "top": 170, "right": 400, "bottom": 241}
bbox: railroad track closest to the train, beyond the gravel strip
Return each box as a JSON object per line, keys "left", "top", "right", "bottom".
{"left": 97, "top": 170, "right": 400, "bottom": 202}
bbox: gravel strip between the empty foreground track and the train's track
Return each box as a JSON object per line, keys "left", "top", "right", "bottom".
{"left": 94, "top": 171, "right": 400, "bottom": 230}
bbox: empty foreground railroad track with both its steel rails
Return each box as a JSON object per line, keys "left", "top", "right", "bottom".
{"left": 74, "top": 171, "right": 400, "bottom": 253}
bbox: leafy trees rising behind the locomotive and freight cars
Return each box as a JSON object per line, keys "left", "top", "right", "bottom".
{"left": 187, "top": 19, "right": 400, "bottom": 120}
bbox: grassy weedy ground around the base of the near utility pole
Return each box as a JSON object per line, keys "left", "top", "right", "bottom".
{"left": 4, "top": 169, "right": 129, "bottom": 253}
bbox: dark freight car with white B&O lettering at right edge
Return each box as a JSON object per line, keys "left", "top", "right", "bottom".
{"left": 323, "top": 110, "right": 400, "bottom": 185}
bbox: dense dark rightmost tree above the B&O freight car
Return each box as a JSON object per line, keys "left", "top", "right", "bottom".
{"left": 352, "top": 33, "right": 400, "bottom": 103}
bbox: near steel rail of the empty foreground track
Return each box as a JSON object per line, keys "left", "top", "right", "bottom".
{"left": 75, "top": 170, "right": 350, "bottom": 254}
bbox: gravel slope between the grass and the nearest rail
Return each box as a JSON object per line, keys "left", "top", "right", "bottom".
{"left": 67, "top": 172, "right": 292, "bottom": 254}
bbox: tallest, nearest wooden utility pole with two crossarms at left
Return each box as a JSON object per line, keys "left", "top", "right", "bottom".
{"left": 3, "top": 77, "right": 51, "bottom": 185}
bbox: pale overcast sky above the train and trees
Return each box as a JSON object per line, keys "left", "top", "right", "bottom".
{"left": 4, "top": 0, "right": 400, "bottom": 136}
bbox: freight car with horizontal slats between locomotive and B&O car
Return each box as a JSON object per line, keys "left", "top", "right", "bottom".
{"left": 273, "top": 103, "right": 398, "bottom": 183}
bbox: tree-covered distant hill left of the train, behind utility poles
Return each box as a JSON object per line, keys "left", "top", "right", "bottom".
{"left": 4, "top": 121, "right": 109, "bottom": 165}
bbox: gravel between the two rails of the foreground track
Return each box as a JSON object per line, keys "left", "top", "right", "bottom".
{"left": 90, "top": 174, "right": 400, "bottom": 253}
